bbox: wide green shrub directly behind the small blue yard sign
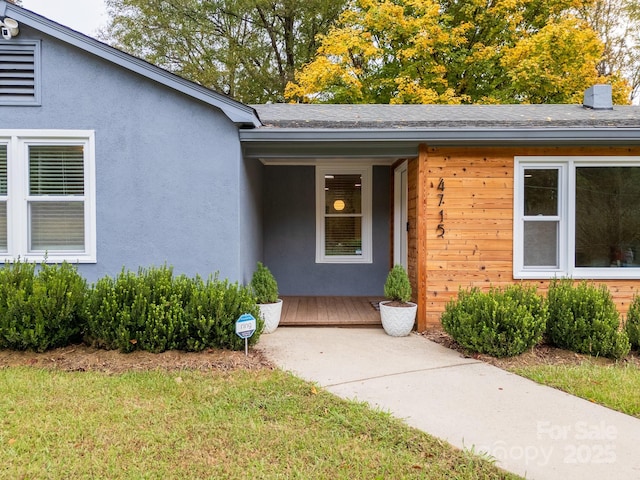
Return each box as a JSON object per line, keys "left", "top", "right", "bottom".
{"left": 87, "top": 266, "right": 262, "bottom": 352}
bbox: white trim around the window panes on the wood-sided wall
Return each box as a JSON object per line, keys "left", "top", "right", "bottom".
{"left": 513, "top": 156, "right": 640, "bottom": 280}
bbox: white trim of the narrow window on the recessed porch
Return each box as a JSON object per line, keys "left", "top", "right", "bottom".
{"left": 316, "top": 164, "right": 373, "bottom": 264}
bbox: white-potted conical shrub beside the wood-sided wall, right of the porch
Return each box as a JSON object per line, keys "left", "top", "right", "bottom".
{"left": 380, "top": 265, "right": 418, "bottom": 337}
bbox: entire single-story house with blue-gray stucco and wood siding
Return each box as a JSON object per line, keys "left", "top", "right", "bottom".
{"left": 0, "top": 0, "right": 640, "bottom": 330}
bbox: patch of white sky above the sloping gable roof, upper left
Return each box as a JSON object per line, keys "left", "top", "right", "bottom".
{"left": 22, "top": 0, "right": 107, "bottom": 37}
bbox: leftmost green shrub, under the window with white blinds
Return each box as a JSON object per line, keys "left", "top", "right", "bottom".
{"left": 0, "top": 260, "right": 87, "bottom": 352}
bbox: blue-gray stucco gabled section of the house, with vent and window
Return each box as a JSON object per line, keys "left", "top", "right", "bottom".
{"left": 0, "top": 1, "right": 262, "bottom": 280}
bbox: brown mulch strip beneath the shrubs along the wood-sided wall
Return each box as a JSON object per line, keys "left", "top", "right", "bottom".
{"left": 422, "top": 329, "right": 640, "bottom": 370}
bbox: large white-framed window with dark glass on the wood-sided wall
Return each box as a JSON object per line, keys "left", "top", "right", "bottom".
{"left": 514, "top": 156, "right": 640, "bottom": 278}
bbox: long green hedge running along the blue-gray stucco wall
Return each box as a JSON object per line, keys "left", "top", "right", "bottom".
{"left": 0, "top": 261, "right": 264, "bottom": 352}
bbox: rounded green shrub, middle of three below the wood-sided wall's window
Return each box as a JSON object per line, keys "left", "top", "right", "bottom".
{"left": 547, "top": 279, "right": 629, "bottom": 358}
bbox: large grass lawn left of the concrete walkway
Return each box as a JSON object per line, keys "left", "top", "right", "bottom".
{"left": 0, "top": 367, "right": 519, "bottom": 479}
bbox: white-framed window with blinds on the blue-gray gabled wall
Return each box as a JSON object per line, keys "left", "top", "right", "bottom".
{"left": 0, "top": 131, "right": 96, "bottom": 262}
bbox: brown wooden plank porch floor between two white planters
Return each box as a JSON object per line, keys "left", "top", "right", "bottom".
{"left": 280, "top": 297, "right": 384, "bottom": 326}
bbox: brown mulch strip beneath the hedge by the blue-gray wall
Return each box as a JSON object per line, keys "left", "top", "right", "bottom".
{"left": 0, "top": 345, "right": 274, "bottom": 374}
